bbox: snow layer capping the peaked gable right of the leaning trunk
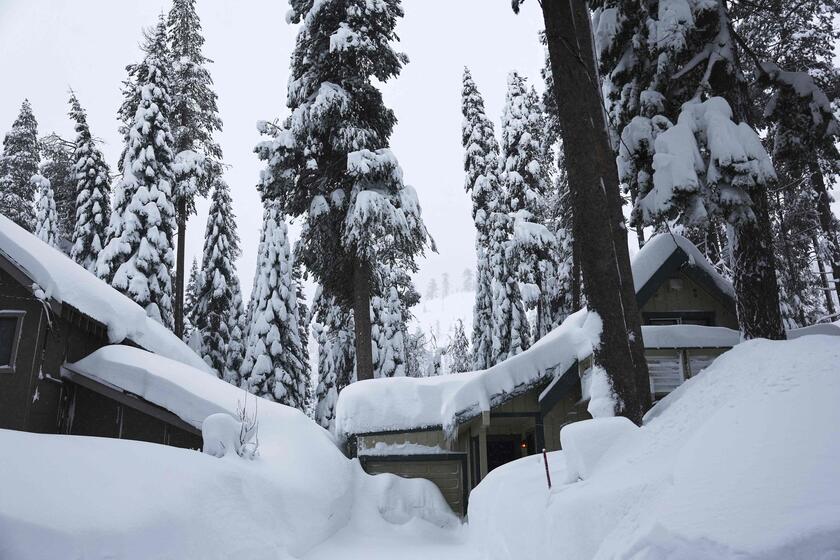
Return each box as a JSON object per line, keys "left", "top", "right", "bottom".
{"left": 632, "top": 233, "right": 735, "bottom": 298}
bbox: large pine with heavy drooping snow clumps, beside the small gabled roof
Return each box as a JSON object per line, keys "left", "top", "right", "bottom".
{"left": 593, "top": 0, "right": 785, "bottom": 339}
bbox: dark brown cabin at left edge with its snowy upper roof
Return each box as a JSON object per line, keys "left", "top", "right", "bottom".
{"left": 0, "top": 216, "right": 210, "bottom": 448}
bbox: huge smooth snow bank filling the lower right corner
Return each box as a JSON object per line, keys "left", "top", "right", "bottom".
{"left": 469, "top": 336, "right": 840, "bottom": 560}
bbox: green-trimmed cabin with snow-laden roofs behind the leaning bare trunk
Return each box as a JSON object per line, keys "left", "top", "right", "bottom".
{"left": 335, "top": 234, "right": 740, "bottom": 515}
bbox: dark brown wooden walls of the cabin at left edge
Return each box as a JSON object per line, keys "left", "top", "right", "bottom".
{"left": 0, "top": 221, "right": 201, "bottom": 449}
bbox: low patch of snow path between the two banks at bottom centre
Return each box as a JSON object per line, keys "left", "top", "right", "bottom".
{"left": 303, "top": 519, "right": 483, "bottom": 560}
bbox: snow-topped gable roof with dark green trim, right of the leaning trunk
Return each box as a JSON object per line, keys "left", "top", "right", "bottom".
{"left": 631, "top": 233, "right": 735, "bottom": 314}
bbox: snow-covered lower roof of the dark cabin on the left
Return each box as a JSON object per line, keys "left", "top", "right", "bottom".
{"left": 65, "top": 344, "right": 236, "bottom": 430}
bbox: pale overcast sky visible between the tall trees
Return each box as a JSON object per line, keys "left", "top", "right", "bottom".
{"left": 0, "top": 0, "right": 543, "bottom": 293}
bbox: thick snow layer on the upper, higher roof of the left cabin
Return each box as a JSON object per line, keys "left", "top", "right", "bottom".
{"left": 0, "top": 215, "right": 210, "bottom": 372}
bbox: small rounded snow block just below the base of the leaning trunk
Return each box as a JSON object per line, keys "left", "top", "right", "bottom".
{"left": 560, "top": 416, "right": 638, "bottom": 482}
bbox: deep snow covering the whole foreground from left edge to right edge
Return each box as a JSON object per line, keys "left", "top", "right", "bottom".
{"left": 0, "top": 335, "right": 840, "bottom": 560}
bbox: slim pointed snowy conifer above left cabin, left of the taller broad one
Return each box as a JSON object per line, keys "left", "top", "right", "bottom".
{"left": 69, "top": 91, "right": 111, "bottom": 274}
